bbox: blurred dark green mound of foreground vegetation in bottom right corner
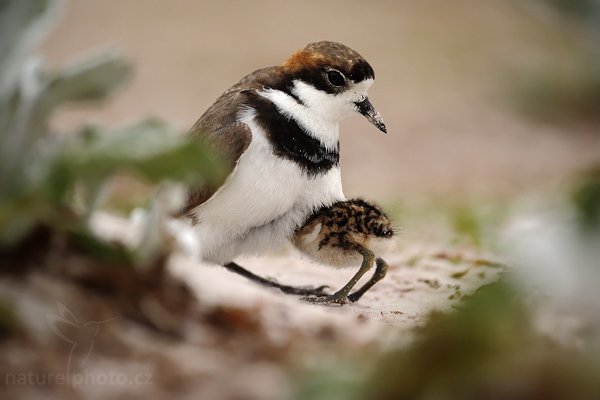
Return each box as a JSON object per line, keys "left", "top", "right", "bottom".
{"left": 296, "top": 282, "right": 600, "bottom": 400}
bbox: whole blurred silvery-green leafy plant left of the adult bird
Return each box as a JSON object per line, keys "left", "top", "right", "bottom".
{"left": 0, "top": 0, "right": 221, "bottom": 254}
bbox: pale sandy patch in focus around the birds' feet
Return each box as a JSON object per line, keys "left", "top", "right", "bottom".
{"left": 174, "top": 248, "right": 504, "bottom": 332}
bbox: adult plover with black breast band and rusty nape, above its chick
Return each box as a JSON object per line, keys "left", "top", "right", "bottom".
{"left": 181, "top": 41, "right": 386, "bottom": 290}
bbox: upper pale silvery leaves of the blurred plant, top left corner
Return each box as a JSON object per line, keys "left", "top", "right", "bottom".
{"left": 0, "top": 0, "right": 131, "bottom": 195}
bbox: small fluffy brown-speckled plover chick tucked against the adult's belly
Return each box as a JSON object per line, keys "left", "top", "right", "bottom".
{"left": 293, "top": 199, "right": 395, "bottom": 304}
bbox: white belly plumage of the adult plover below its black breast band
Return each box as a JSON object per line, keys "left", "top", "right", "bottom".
{"left": 190, "top": 117, "right": 344, "bottom": 263}
